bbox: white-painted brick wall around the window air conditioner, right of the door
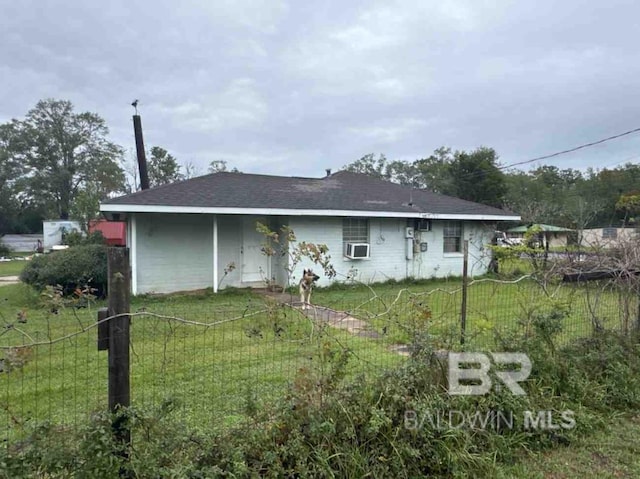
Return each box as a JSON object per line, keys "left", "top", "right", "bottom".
{"left": 289, "top": 217, "right": 494, "bottom": 286}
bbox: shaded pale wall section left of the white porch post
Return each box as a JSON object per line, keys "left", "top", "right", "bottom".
{"left": 136, "top": 214, "right": 213, "bottom": 294}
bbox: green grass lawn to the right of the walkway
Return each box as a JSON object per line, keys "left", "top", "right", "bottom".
{"left": 313, "top": 278, "right": 637, "bottom": 349}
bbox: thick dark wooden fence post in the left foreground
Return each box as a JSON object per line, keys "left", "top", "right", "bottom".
{"left": 107, "top": 248, "right": 131, "bottom": 445}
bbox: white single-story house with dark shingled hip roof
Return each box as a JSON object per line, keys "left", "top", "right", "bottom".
{"left": 100, "top": 171, "right": 520, "bottom": 294}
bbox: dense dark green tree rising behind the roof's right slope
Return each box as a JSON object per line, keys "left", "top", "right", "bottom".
{"left": 446, "top": 147, "right": 507, "bottom": 208}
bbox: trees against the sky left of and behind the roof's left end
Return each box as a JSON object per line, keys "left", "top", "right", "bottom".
{"left": 0, "top": 99, "right": 235, "bottom": 235}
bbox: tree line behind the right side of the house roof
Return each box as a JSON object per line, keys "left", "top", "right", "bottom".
{"left": 344, "top": 152, "right": 640, "bottom": 229}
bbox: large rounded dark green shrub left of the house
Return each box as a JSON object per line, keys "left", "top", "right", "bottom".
{"left": 20, "top": 244, "right": 107, "bottom": 295}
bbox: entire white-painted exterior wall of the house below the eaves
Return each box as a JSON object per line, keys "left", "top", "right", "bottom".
{"left": 129, "top": 214, "right": 493, "bottom": 294}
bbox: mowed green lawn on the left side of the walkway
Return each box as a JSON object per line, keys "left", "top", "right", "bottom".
{"left": 0, "top": 284, "right": 402, "bottom": 435}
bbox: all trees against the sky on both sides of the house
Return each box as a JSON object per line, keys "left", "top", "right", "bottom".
{"left": 0, "top": 99, "right": 640, "bottom": 234}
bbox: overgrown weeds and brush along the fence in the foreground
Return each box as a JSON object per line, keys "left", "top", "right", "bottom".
{"left": 0, "top": 312, "right": 640, "bottom": 478}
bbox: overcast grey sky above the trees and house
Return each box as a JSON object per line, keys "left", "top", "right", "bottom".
{"left": 0, "top": 0, "right": 640, "bottom": 177}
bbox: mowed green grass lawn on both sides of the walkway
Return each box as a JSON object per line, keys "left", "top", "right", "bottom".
{"left": 0, "top": 279, "right": 636, "bottom": 444}
